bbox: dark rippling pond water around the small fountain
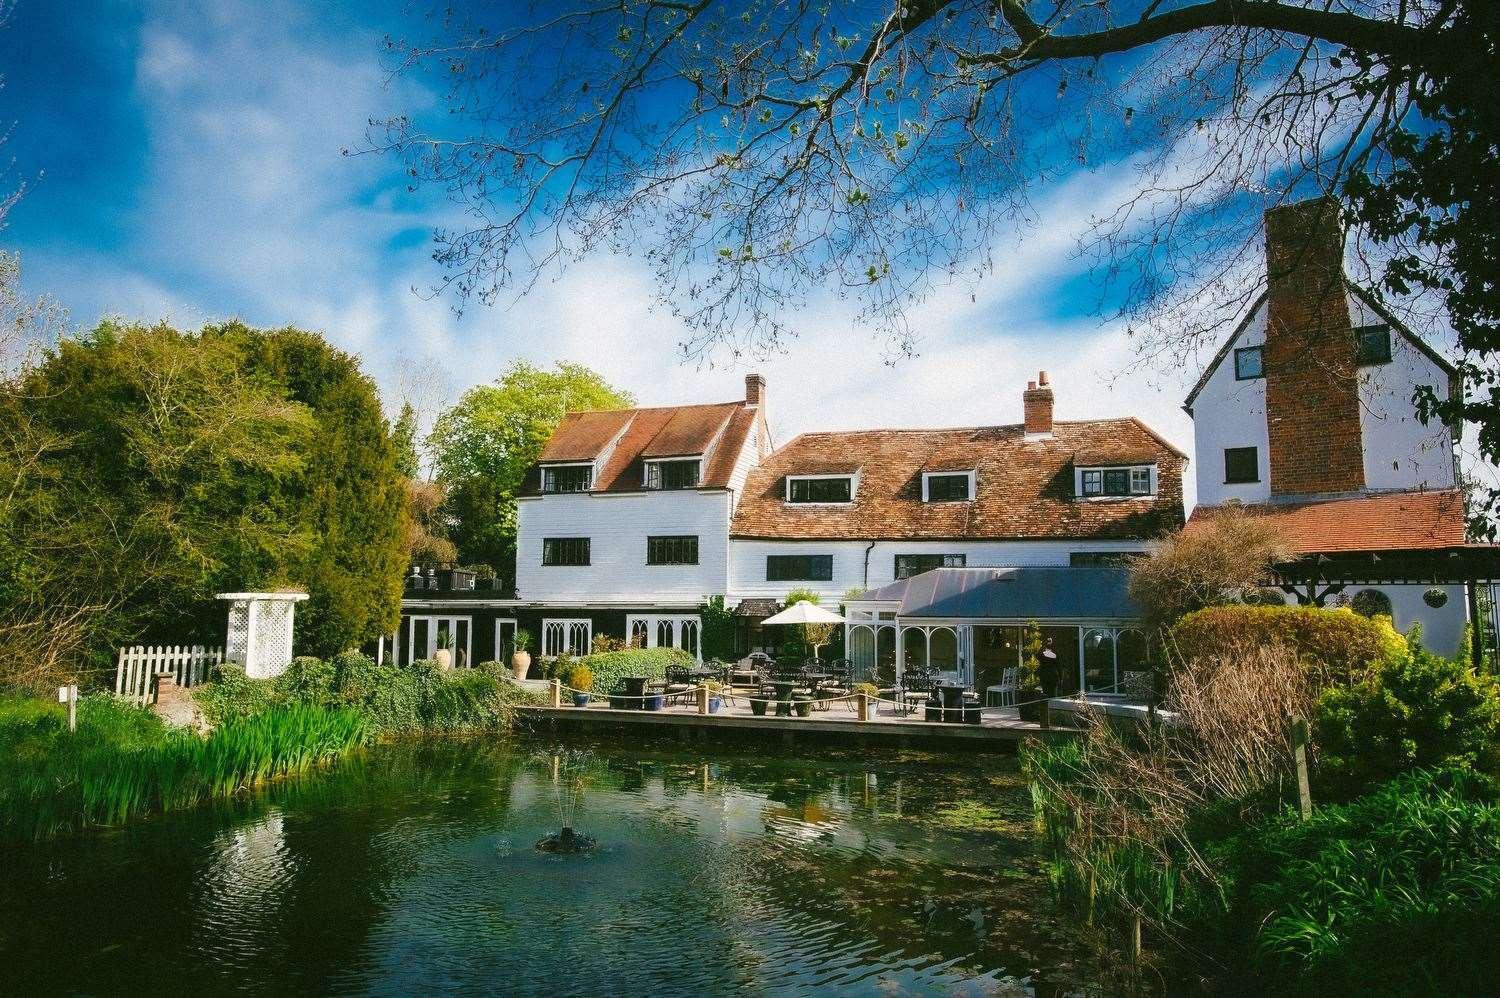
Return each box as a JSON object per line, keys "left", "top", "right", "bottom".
{"left": 0, "top": 740, "right": 1092, "bottom": 995}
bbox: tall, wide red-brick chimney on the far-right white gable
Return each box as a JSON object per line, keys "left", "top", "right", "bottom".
{"left": 1263, "top": 198, "right": 1365, "bottom": 495}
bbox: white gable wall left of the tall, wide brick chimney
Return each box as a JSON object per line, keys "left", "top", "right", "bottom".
{"left": 1193, "top": 303, "right": 1271, "bottom": 506}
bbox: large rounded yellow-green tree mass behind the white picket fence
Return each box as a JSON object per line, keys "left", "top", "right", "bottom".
{"left": 0, "top": 321, "right": 405, "bottom": 680}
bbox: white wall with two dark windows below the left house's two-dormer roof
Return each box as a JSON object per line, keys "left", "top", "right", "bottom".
{"left": 516, "top": 489, "right": 731, "bottom": 603}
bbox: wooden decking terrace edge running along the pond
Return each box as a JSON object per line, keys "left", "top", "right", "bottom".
{"left": 519, "top": 698, "right": 1077, "bottom": 749}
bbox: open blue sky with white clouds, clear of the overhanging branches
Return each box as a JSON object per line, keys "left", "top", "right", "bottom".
{"left": 0, "top": 0, "right": 1206, "bottom": 504}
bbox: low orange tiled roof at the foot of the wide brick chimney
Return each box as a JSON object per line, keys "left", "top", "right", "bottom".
{"left": 1191, "top": 489, "right": 1466, "bottom": 554}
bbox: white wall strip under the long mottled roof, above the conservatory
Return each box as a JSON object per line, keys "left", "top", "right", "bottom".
{"left": 729, "top": 539, "right": 1151, "bottom": 608}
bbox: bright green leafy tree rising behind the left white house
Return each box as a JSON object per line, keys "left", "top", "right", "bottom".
{"left": 428, "top": 360, "right": 635, "bottom": 579}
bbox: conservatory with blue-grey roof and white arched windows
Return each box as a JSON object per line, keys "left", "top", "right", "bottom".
{"left": 845, "top": 567, "right": 1148, "bottom": 696}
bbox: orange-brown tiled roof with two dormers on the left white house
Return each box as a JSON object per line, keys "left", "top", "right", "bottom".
{"left": 534, "top": 402, "right": 755, "bottom": 495}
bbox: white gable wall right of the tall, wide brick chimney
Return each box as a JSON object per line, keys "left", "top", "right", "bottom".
{"left": 1349, "top": 296, "right": 1455, "bottom": 489}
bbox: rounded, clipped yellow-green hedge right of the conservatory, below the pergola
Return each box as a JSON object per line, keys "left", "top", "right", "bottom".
{"left": 1172, "top": 606, "right": 1407, "bottom": 681}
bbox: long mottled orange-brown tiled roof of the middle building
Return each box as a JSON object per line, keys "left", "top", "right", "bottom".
{"left": 731, "top": 419, "right": 1185, "bottom": 540}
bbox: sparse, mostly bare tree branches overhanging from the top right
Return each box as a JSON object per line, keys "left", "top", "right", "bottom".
{"left": 384, "top": 0, "right": 1500, "bottom": 513}
